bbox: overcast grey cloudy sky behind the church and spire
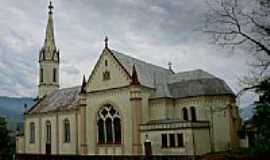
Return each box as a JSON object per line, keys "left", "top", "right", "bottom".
{"left": 0, "top": 0, "right": 255, "bottom": 107}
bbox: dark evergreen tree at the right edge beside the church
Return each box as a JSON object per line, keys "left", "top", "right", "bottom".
{"left": 253, "top": 78, "right": 270, "bottom": 154}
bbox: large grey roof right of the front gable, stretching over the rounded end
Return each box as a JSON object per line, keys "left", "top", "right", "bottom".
{"left": 112, "top": 50, "right": 234, "bottom": 98}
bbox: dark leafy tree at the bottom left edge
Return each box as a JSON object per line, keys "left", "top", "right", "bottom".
{"left": 0, "top": 117, "right": 15, "bottom": 160}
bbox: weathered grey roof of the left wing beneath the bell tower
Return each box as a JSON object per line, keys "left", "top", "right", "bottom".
{"left": 27, "top": 86, "right": 81, "bottom": 114}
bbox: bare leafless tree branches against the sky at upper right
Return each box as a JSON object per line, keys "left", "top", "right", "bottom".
{"left": 203, "top": 0, "right": 270, "bottom": 87}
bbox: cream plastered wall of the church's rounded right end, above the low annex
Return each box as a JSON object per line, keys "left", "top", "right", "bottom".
{"left": 176, "top": 96, "right": 231, "bottom": 151}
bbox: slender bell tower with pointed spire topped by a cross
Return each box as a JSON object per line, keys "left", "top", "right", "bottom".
{"left": 38, "top": 1, "right": 60, "bottom": 98}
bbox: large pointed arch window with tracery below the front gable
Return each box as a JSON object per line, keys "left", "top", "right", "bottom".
{"left": 97, "top": 104, "right": 121, "bottom": 144}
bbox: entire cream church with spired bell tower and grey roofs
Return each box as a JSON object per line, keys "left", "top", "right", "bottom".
{"left": 16, "top": 3, "right": 239, "bottom": 155}
